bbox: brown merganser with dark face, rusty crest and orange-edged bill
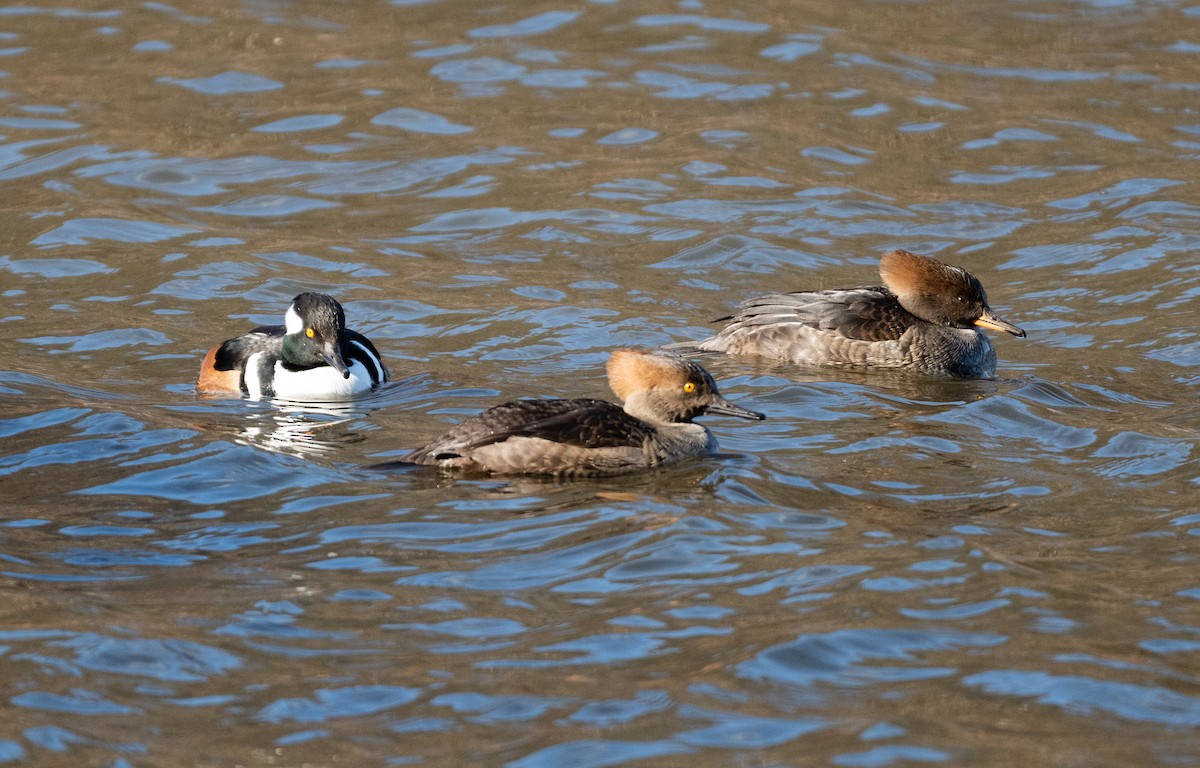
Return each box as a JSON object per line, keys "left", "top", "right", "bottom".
{"left": 676, "top": 251, "right": 1025, "bottom": 378}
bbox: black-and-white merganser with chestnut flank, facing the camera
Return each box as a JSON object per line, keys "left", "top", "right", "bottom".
{"left": 196, "top": 293, "right": 388, "bottom": 401}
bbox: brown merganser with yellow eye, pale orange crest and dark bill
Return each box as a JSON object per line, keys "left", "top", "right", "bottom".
{"left": 401, "top": 349, "right": 766, "bottom": 478}
